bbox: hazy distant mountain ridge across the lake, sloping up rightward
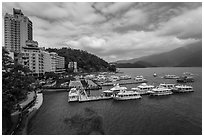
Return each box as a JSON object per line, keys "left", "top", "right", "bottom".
{"left": 115, "top": 41, "right": 202, "bottom": 67}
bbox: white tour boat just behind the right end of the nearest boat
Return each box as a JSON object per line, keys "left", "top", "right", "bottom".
{"left": 131, "top": 83, "right": 154, "bottom": 95}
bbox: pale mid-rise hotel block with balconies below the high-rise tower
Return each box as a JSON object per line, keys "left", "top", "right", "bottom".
{"left": 19, "top": 46, "right": 65, "bottom": 74}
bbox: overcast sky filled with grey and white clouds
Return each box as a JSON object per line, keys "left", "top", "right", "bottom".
{"left": 2, "top": 2, "right": 202, "bottom": 61}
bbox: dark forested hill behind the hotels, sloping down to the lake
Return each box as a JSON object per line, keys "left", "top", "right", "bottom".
{"left": 46, "top": 47, "right": 115, "bottom": 72}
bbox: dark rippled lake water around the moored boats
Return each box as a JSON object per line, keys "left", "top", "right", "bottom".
{"left": 28, "top": 67, "right": 202, "bottom": 135}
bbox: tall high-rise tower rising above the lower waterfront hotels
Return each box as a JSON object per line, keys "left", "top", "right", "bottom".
{"left": 4, "top": 9, "right": 33, "bottom": 53}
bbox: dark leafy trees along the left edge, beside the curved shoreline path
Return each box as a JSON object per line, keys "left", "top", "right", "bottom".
{"left": 2, "top": 48, "right": 34, "bottom": 132}
